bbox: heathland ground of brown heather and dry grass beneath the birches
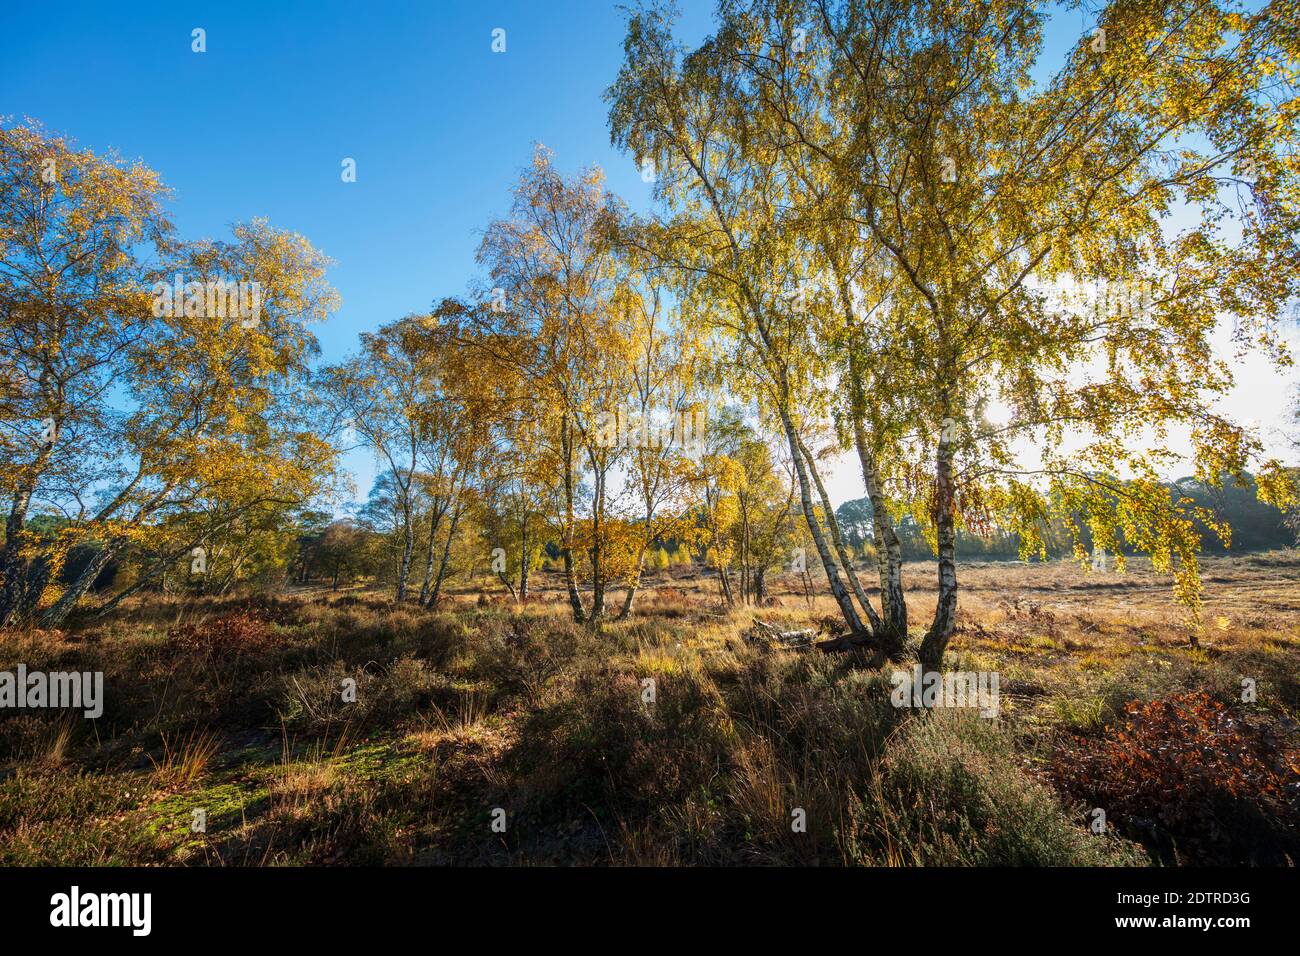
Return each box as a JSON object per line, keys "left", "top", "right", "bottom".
{"left": 0, "top": 551, "right": 1300, "bottom": 865}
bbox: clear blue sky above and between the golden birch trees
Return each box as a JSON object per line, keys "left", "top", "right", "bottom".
{"left": 0, "top": 0, "right": 1295, "bottom": 501}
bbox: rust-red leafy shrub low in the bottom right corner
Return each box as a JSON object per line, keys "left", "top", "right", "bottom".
{"left": 1052, "top": 693, "right": 1300, "bottom": 865}
